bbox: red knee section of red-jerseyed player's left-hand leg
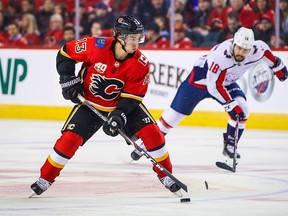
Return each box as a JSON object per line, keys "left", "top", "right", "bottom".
{"left": 54, "top": 131, "right": 83, "bottom": 159}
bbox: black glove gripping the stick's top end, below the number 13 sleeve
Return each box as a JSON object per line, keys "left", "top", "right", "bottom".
{"left": 60, "top": 76, "right": 83, "bottom": 103}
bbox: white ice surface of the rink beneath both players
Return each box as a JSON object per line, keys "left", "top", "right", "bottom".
{"left": 0, "top": 119, "right": 288, "bottom": 216}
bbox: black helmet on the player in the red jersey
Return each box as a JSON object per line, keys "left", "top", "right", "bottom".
{"left": 114, "top": 15, "right": 145, "bottom": 43}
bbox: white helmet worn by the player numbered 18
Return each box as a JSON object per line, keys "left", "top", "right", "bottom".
{"left": 233, "top": 27, "right": 255, "bottom": 49}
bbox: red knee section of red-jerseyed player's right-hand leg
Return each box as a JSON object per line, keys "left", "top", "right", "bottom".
{"left": 136, "top": 124, "right": 165, "bottom": 151}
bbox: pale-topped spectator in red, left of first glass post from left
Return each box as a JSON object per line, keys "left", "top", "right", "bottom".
{"left": 44, "top": 14, "right": 64, "bottom": 47}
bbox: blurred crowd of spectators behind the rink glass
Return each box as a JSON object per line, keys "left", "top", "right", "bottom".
{"left": 0, "top": 0, "right": 288, "bottom": 49}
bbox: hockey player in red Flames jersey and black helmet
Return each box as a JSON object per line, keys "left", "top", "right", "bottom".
{"left": 31, "top": 16, "right": 180, "bottom": 195}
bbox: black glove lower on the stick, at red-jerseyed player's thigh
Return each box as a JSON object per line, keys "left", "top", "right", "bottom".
{"left": 102, "top": 111, "right": 127, "bottom": 137}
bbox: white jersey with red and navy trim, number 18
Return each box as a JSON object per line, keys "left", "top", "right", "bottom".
{"left": 189, "top": 39, "right": 276, "bottom": 103}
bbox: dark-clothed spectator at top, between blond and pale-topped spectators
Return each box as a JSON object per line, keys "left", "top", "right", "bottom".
{"left": 36, "top": 0, "right": 55, "bottom": 38}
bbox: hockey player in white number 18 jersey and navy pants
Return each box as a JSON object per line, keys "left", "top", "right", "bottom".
{"left": 131, "top": 27, "right": 288, "bottom": 160}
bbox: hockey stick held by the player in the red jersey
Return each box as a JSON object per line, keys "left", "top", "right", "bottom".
{"left": 78, "top": 94, "right": 188, "bottom": 192}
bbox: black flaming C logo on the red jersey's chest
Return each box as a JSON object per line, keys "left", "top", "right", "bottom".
{"left": 89, "top": 74, "right": 124, "bottom": 100}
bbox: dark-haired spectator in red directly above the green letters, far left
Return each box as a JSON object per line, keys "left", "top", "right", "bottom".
{"left": 5, "top": 22, "right": 28, "bottom": 48}
